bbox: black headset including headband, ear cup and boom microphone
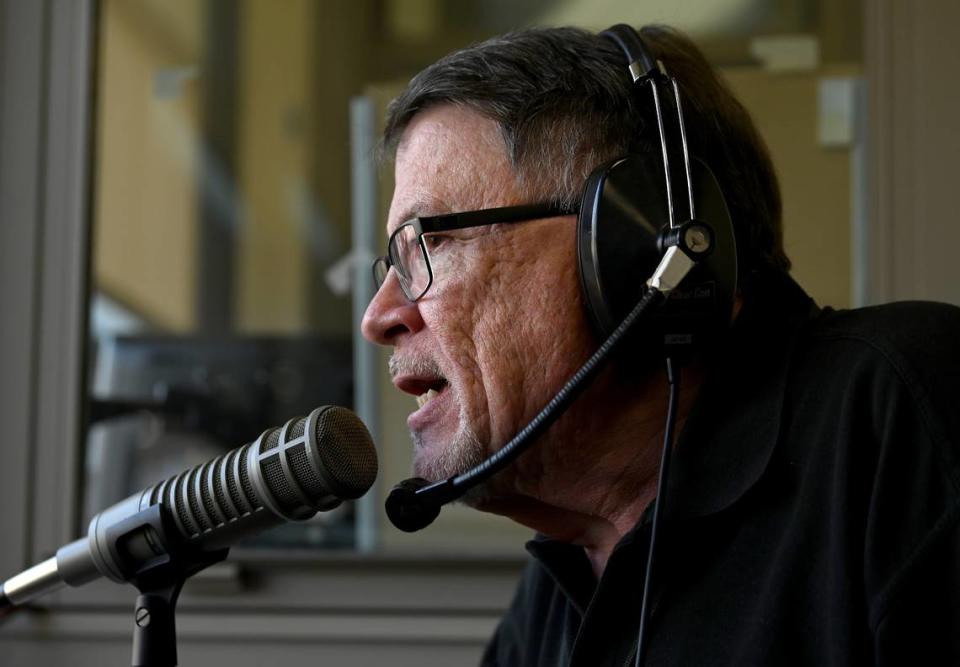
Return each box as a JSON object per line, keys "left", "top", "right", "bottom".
{"left": 385, "top": 24, "right": 737, "bottom": 532}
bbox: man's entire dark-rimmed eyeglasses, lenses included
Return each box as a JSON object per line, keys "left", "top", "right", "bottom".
{"left": 373, "top": 202, "right": 577, "bottom": 301}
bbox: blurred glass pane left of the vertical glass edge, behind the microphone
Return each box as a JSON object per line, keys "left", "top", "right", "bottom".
{"left": 84, "top": 0, "right": 357, "bottom": 547}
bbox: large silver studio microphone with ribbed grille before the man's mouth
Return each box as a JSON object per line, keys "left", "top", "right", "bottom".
{"left": 0, "top": 406, "right": 377, "bottom": 610}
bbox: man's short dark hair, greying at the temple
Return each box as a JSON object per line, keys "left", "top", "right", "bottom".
{"left": 383, "top": 26, "right": 790, "bottom": 270}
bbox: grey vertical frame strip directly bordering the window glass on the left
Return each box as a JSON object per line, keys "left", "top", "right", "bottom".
{"left": 32, "top": 0, "right": 94, "bottom": 558}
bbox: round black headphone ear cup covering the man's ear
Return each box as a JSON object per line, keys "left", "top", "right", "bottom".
{"left": 577, "top": 155, "right": 737, "bottom": 358}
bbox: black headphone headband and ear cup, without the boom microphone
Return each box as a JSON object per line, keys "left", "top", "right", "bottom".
{"left": 577, "top": 24, "right": 737, "bottom": 360}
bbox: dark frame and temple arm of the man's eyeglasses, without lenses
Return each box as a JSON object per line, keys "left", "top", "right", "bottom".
{"left": 373, "top": 202, "right": 578, "bottom": 301}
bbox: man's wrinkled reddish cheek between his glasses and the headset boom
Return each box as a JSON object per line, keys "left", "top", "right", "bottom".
{"left": 421, "top": 230, "right": 592, "bottom": 431}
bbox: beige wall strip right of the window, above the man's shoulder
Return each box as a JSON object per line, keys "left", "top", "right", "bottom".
{"left": 865, "top": 0, "right": 960, "bottom": 304}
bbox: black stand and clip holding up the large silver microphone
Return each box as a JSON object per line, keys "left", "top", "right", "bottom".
{"left": 101, "top": 502, "right": 230, "bottom": 667}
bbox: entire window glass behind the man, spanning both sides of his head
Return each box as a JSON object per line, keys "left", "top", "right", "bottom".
{"left": 83, "top": 0, "right": 861, "bottom": 554}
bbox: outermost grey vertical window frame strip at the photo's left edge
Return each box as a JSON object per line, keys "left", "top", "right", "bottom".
{"left": 0, "top": 0, "right": 49, "bottom": 576}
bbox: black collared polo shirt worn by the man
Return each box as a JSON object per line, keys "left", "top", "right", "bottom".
{"left": 484, "top": 276, "right": 960, "bottom": 667}
